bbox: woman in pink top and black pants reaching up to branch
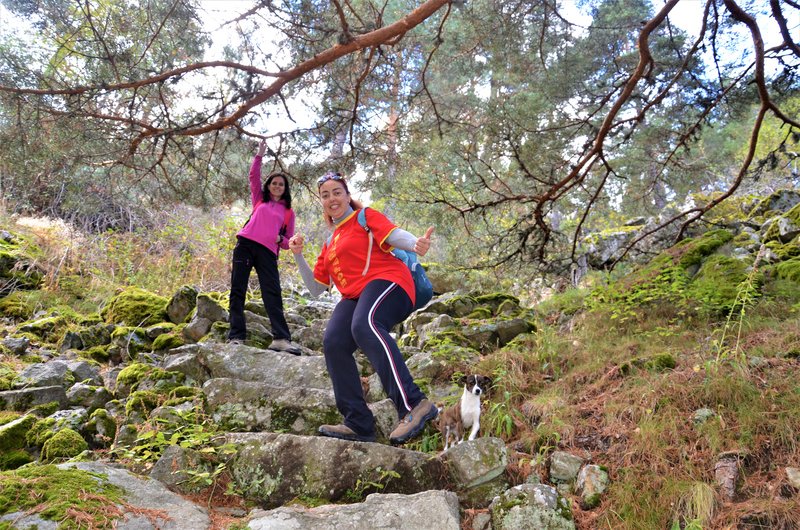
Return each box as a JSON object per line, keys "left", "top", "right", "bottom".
{"left": 228, "top": 140, "right": 300, "bottom": 355}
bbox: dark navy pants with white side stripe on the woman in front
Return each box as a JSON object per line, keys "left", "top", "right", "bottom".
{"left": 323, "top": 280, "right": 425, "bottom": 435}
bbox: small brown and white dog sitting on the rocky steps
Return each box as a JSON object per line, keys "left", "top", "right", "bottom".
{"left": 438, "top": 375, "right": 492, "bottom": 451}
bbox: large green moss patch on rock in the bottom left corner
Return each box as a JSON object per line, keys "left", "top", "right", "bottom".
{"left": 0, "top": 465, "right": 122, "bottom": 530}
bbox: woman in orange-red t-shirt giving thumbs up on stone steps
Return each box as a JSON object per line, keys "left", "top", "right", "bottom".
{"left": 289, "top": 172, "right": 438, "bottom": 444}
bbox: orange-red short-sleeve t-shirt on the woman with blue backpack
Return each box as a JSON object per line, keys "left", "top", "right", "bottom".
{"left": 314, "top": 208, "right": 416, "bottom": 305}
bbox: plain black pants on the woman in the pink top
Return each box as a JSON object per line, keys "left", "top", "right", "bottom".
{"left": 228, "top": 237, "right": 292, "bottom": 340}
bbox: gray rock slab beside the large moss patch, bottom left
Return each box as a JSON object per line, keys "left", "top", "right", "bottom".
{"left": 59, "top": 462, "right": 211, "bottom": 530}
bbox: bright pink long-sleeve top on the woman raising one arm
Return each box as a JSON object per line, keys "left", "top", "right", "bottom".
{"left": 236, "top": 155, "right": 294, "bottom": 256}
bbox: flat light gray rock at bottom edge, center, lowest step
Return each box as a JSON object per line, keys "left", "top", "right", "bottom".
{"left": 247, "top": 490, "right": 460, "bottom": 530}
